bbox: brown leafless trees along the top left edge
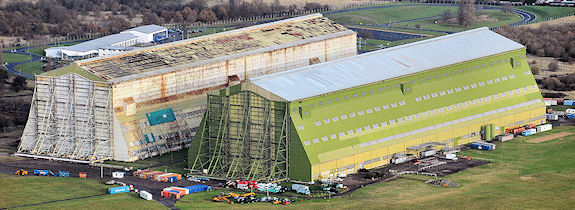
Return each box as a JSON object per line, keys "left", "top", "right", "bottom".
{"left": 0, "top": 0, "right": 328, "bottom": 39}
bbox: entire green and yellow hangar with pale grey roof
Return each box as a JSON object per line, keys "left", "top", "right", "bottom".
{"left": 189, "top": 28, "right": 545, "bottom": 181}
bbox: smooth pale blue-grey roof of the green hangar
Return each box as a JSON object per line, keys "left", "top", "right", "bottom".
{"left": 250, "top": 27, "right": 524, "bottom": 101}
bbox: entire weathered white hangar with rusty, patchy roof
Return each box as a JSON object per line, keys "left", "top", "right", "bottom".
{"left": 17, "top": 14, "right": 357, "bottom": 162}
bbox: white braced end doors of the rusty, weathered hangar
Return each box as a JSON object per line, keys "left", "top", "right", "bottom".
{"left": 17, "top": 74, "right": 112, "bottom": 162}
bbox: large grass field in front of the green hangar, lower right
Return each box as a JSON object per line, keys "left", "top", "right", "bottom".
{"left": 176, "top": 127, "right": 575, "bottom": 209}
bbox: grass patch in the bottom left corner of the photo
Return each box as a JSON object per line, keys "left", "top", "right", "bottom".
{"left": 0, "top": 175, "right": 165, "bottom": 209}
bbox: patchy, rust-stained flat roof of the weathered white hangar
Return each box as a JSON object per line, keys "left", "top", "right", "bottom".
{"left": 73, "top": 14, "right": 348, "bottom": 82}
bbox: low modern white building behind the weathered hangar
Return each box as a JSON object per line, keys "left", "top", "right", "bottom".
{"left": 44, "top": 25, "right": 168, "bottom": 60}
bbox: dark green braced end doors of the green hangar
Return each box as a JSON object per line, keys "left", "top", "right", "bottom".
{"left": 192, "top": 87, "right": 289, "bottom": 182}
